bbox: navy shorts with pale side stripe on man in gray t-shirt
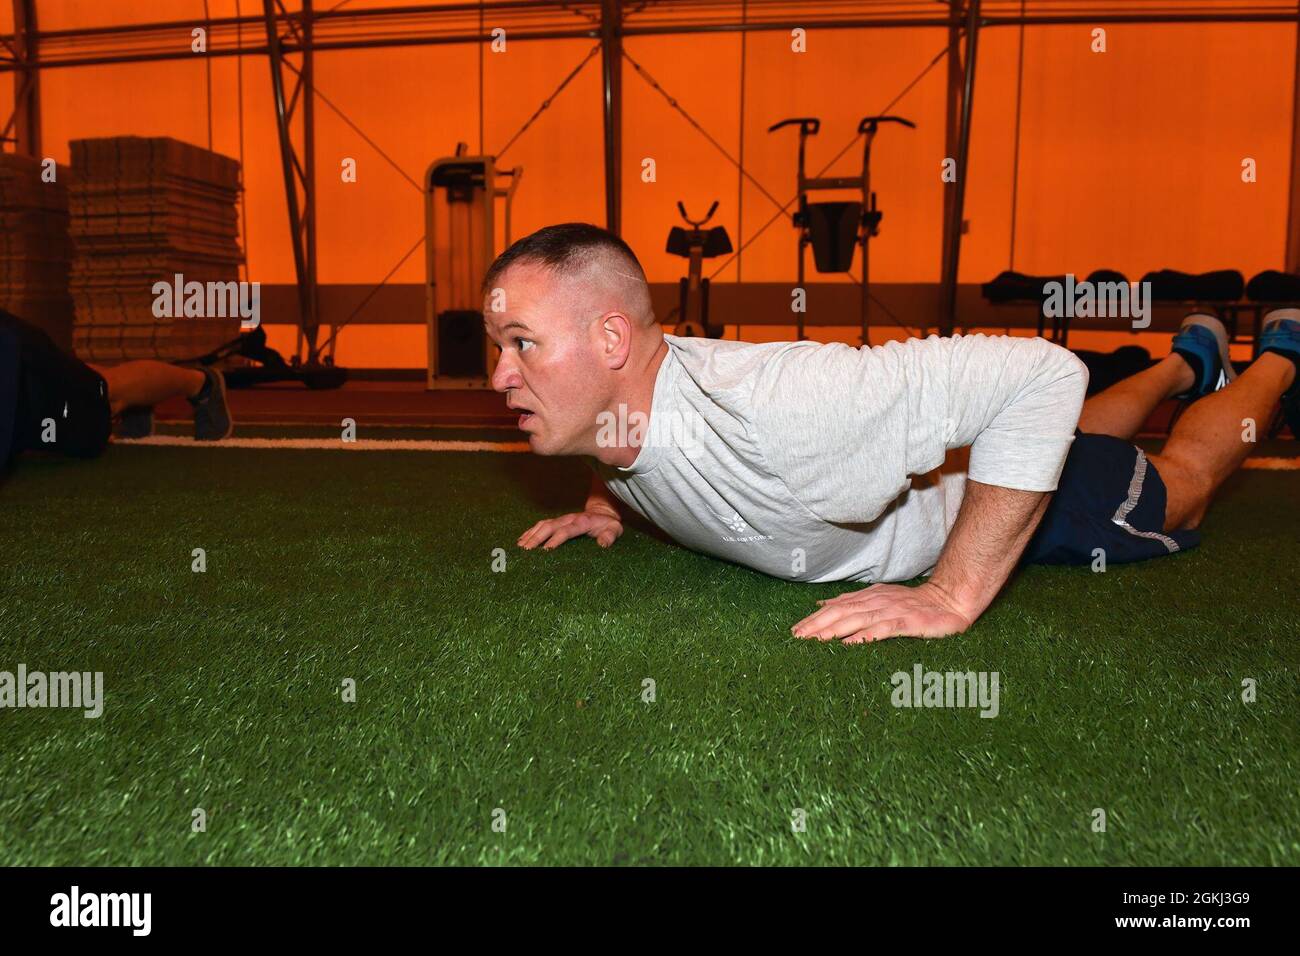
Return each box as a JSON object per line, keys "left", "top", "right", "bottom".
{"left": 1021, "top": 432, "right": 1201, "bottom": 564}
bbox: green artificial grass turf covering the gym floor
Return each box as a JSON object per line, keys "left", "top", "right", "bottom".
{"left": 0, "top": 447, "right": 1300, "bottom": 865}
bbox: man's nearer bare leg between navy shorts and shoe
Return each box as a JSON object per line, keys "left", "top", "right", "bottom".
{"left": 1151, "top": 352, "right": 1296, "bottom": 531}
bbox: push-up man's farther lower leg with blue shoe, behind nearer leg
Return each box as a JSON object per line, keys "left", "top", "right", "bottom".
{"left": 1079, "top": 313, "right": 1235, "bottom": 441}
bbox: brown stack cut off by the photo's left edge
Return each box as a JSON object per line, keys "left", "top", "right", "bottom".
{"left": 0, "top": 153, "right": 73, "bottom": 349}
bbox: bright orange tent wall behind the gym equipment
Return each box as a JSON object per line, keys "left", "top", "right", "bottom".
{"left": 12, "top": 0, "right": 1296, "bottom": 367}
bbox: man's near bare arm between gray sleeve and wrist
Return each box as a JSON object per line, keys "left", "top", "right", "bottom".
{"left": 930, "top": 480, "right": 1052, "bottom": 622}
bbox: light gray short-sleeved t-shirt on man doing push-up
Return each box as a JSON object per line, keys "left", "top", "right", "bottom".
{"left": 592, "top": 334, "right": 1088, "bottom": 581}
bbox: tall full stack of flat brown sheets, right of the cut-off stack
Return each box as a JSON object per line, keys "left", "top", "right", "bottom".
{"left": 70, "top": 137, "right": 243, "bottom": 360}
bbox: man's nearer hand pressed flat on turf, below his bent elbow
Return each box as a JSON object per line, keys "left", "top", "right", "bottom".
{"left": 790, "top": 581, "right": 975, "bottom": 644}
